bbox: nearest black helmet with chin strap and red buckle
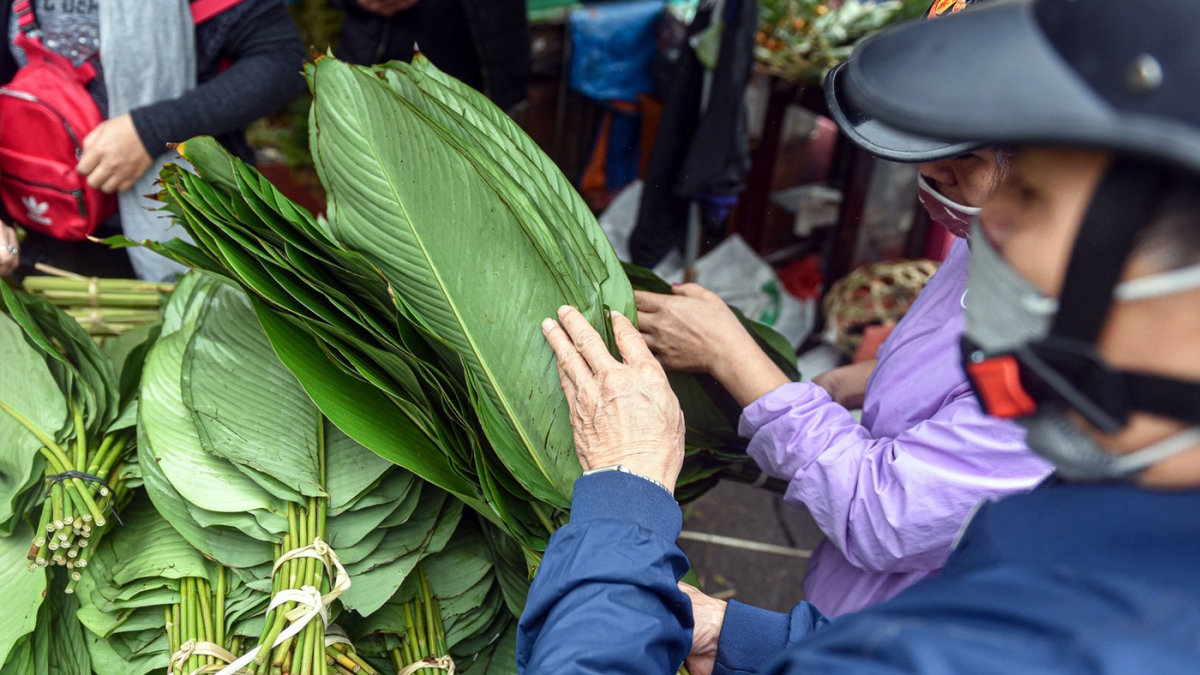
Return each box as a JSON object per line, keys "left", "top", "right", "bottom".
{"left": 836, "top": 0, "right": 1200, "bottom": 432}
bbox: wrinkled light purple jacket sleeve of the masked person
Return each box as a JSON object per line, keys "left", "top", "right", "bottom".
{"left": 739, "top": 382, "right": 1049, "bottom": 573}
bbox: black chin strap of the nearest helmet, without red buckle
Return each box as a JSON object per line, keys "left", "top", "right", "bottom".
{"left": 969, "top": 159, "right": 1200, "bottom": 434}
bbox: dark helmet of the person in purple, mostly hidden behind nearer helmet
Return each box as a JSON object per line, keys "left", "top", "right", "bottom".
{"left": 826, "top": 0, "right": 985, "bottom": 162}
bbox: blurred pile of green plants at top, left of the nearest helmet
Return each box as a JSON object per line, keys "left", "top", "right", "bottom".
{"left": 755, "top": 0, "right": 929, "bottom": 85}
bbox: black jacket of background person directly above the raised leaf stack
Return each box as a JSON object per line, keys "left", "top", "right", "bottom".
{"left": 330, "top": 0, "right": 533, "bottom": 110}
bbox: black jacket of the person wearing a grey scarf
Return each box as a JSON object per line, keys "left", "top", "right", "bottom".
{"left": 0, "top": 0, "right": 305, "bottom": 162}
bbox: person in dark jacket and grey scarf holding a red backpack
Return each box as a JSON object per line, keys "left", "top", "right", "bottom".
{"left": 0, "top": 0, "right": 304, "bottom": 281}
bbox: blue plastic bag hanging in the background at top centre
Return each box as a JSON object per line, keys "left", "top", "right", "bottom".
{"left": 571, "top": 0, "right": 666, "bottom": 101}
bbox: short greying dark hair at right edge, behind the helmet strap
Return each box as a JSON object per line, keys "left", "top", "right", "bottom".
{"left": 1138, "top": 173, "right": 1200, "bottom": 270}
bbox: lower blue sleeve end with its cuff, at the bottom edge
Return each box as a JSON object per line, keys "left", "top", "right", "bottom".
{"left": 713, "top": 601, "right": 832, "bottom": 675}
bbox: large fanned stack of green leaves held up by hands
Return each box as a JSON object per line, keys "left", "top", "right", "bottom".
{"left": 140, "top": 58, "right": 796, "bottom": 561}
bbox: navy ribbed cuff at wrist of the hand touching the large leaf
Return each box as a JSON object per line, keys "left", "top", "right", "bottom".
{"left": 571, "top": 471, "right": 683, "bottom": 542}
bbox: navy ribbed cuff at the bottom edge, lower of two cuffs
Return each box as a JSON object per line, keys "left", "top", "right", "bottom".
{"left": 713, "top": 601, "right": 791, "bottom": 675}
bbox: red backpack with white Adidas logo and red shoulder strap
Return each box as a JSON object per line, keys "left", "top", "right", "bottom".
{"left": 0, "top": 0, "right": 241, "bottom": 241}
